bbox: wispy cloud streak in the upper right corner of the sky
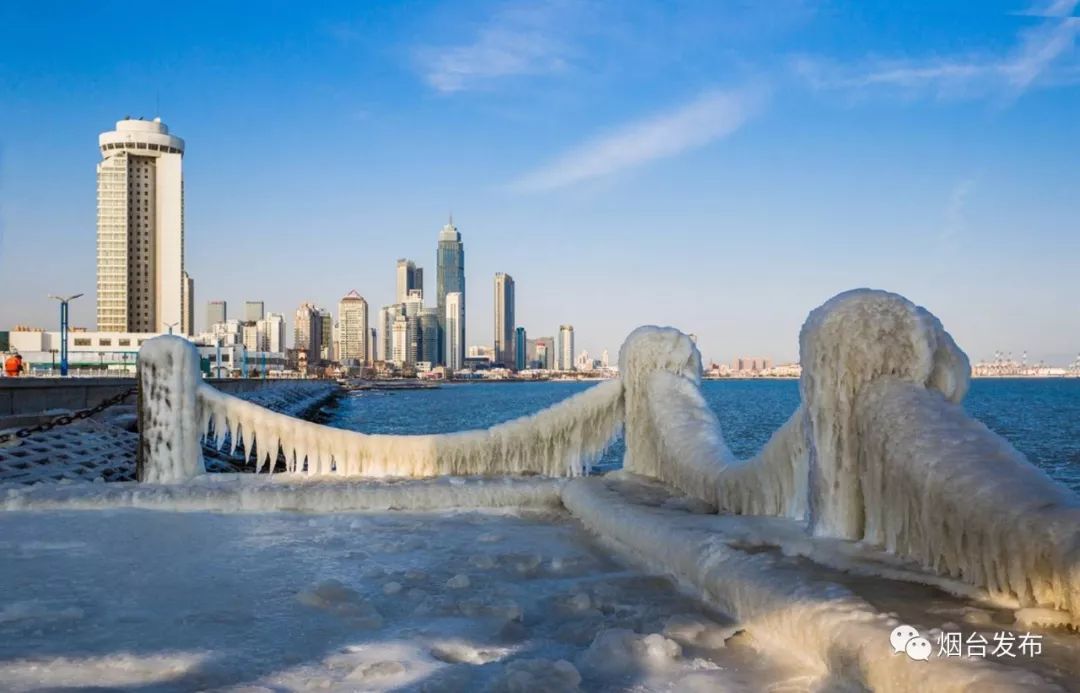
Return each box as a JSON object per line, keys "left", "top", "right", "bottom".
{"left": 794, "top": 0, "right": 1080, "bottom": 99}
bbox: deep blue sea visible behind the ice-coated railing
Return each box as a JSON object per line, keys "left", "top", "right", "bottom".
{"left": 325, "top": 379, "right": 1080, "bottom": 492}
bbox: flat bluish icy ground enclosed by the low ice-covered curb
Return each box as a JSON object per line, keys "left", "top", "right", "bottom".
{"left": 0, "top": 500, "right": 818, "bottom": 691}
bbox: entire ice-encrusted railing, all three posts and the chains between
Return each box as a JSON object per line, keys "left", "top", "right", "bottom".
{"left": 140, "top": 289, "right": 1080, "bottom": 622}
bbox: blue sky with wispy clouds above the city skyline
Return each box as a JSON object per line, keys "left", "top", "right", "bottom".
{"left": 0, "top": 0, "right": 1080, "bottom": 363}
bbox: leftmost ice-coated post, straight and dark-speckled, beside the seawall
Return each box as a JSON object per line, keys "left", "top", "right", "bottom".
{"left": 135, "top": 335, "right": 205, "bottom": 484}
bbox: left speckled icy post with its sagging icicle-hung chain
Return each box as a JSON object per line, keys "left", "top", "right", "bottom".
{"left": 133, "top": 336, "right": 622, "bottom": 483}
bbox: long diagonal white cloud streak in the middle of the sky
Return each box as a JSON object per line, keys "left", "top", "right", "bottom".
{"left": 511, "top": 89, "right": 765, "bottom": 191}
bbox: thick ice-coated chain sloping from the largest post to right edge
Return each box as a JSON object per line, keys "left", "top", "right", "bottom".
{"left": 852, "top": 378, "right": 1080, "bottom": 625}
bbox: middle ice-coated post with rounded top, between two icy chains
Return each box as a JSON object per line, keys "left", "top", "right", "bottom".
{"left": 619, "top": 325, "right": 701, "bottom": 478}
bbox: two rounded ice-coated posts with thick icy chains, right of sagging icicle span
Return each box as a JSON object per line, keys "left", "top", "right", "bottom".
{"left": 620, "top": 289, "right": 1080, "bottom": 620}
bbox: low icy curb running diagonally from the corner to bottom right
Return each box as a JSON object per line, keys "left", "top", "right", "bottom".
{"left": 563, "top": 478, "right": 1053, "bottom": 691}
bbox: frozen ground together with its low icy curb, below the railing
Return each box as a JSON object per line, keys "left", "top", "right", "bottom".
{"left": 0, "top": 473, "right": 1080, "bottom": 691}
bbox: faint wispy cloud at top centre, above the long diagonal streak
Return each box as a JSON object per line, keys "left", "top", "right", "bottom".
{"left": 418, "top": 0, "right": 572, "bottom": 93}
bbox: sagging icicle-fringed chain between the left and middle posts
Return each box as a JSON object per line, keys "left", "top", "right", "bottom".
{"left": 191, "top": 381, "right": 622, "bottom": 477}
